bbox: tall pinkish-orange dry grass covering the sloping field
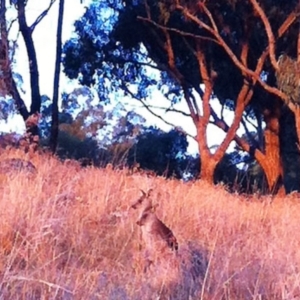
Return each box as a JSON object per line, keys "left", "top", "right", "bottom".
{"left": 0, "top": 152, "right": 300, "bottom": 300}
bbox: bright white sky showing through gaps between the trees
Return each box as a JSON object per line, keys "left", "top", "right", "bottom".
{"left": 1, "top": 0, "right": 253, "bottom": 153}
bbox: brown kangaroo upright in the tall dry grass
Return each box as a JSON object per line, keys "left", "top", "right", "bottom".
{"left": 131, "top": 190, "right": 178, "bottom": 271}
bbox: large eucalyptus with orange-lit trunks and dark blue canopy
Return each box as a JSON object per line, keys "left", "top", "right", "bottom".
{"left": 64, "top": 0, "right": 300, "bottom": 190}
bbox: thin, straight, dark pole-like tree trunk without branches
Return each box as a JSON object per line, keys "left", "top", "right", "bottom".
{"left": 50, "top": 0, "right": 65, "bottom": 153}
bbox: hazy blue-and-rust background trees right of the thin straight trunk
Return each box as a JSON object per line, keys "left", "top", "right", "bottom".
{"left": 45, "top": 87, "right": 145, "bottom": 166}
